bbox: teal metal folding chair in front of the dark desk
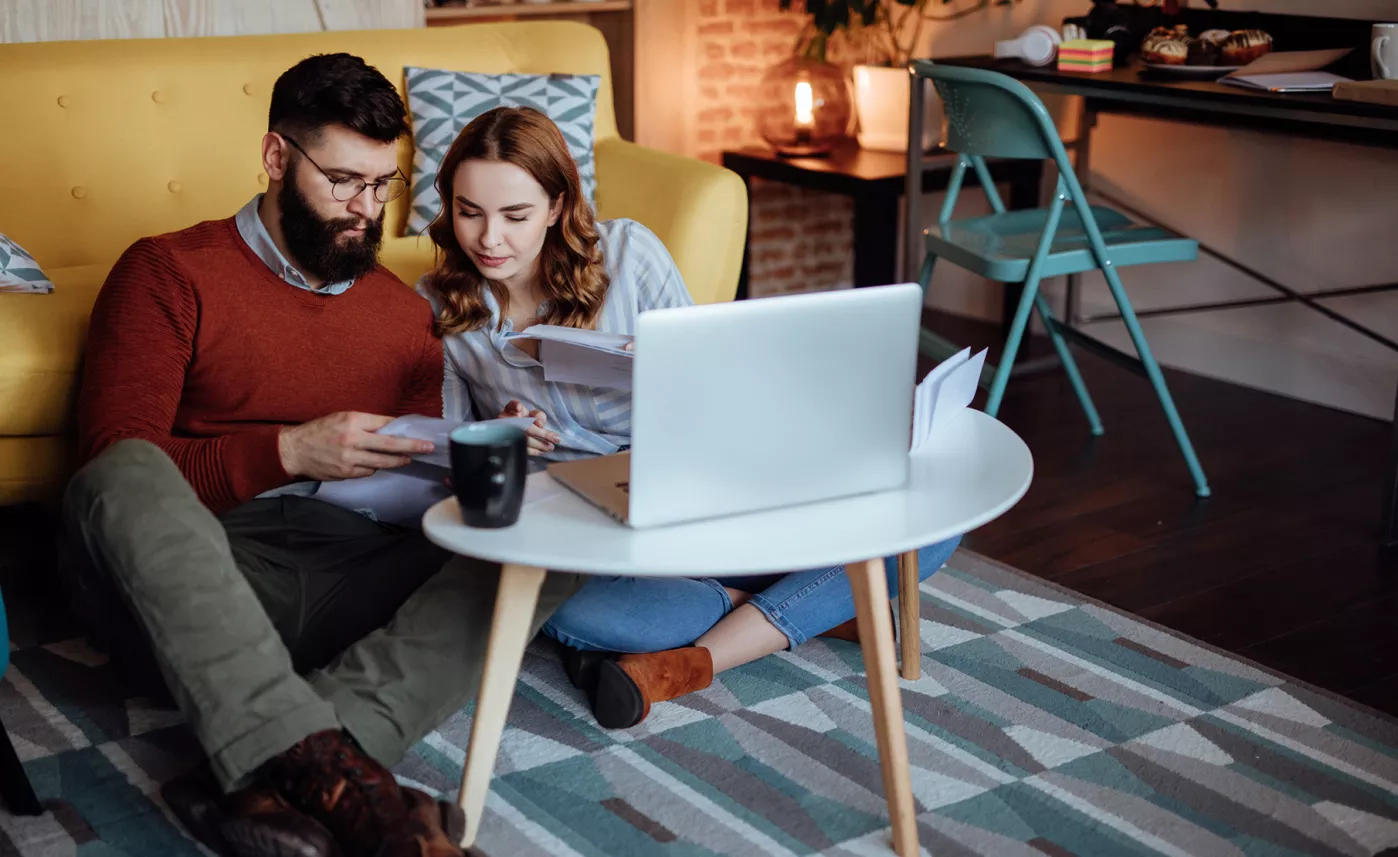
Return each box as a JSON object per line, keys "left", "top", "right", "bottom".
{"left": 909, "top": 60, "right": 1209, "bottom": 496}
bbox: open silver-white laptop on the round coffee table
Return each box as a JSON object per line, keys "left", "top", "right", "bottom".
{"left": 548, "top": 284, "right": 923, "bottom": 527}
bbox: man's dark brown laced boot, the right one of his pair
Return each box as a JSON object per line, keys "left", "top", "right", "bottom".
{"left": 264, "top": 730, "right": 408, "bottom": 857}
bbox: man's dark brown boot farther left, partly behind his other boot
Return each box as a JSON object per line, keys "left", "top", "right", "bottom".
{"left": 161, "top": 765, "right": 340, "bottom": 857}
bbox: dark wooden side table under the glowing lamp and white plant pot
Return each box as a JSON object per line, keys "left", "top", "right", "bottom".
{"left": 723, "top": 141, "right": 1043, "bottom": 327}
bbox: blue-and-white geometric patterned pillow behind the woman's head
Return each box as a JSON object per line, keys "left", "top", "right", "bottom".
{"left": 404, "top": 66, "right": 601, "bottom": 235}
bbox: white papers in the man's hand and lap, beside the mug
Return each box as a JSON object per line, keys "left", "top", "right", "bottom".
{"left": 316, "top": 415, "right": 534, "bottom": 527}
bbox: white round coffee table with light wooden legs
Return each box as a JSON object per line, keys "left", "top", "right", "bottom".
{"left": 422, "top": 410, "right": 1033, "bottom": 856}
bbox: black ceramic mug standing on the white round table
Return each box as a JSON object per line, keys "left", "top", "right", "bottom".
{"left": 449, "top": 422, "right": 528, "bottom": 530}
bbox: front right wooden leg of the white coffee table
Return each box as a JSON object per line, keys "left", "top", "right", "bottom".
{"left": 844, "top": 559, "right": 918, "bottom": 857}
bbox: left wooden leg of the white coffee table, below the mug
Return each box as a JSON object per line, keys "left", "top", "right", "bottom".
{"left": 457, "top": 565, "right": 545, "bottom": 847}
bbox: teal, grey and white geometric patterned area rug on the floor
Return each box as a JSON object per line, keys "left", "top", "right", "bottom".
{"left": 0, "top": 551, "right": 1398, "bottom": 857}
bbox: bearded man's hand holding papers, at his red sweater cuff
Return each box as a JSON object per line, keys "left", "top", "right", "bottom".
{"left": 277, "top": 411, "right": 432, "bottom": 481}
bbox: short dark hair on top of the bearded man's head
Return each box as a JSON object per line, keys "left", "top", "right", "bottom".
{"left": 267, "top": 53, "right": 408, "bottom": 145}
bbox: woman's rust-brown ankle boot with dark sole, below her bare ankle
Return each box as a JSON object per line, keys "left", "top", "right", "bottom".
{"left": 593, "top": 646, "right": 713, "bottom": 728}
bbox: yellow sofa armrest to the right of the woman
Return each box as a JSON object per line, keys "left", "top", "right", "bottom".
{"left": 596, "top": 137, "right": 748, "bottom": 303}
